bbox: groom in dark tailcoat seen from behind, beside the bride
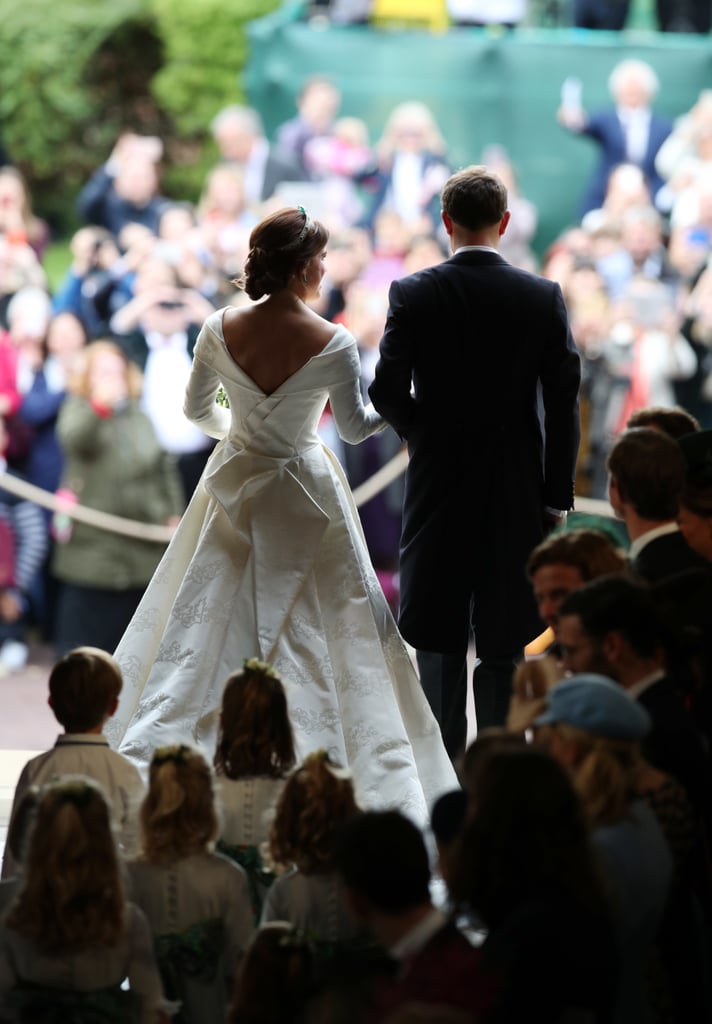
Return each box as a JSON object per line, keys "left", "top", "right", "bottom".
{"left": 369, "top": 166, "right": 580, "bottom": 758}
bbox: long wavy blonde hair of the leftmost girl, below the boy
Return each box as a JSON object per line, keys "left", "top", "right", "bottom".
{"left": 5, "top": 776, "right": 124, "bottom": 955}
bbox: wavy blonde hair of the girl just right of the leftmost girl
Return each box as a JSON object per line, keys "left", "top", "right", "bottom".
{"left": 140, "top": 744, "right": 218, "bottom": 864}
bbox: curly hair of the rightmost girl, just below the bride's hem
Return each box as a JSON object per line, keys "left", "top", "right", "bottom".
{"left": 269, "top": 751, "right": 361, "bottom": 874}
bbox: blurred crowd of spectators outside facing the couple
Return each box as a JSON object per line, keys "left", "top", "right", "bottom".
{"left": 0, "top": 59, "right": 712, "bottom": 664}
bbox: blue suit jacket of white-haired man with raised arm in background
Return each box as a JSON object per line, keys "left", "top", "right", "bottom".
{"left": 581, "top": 110, "right": 672, "bottom": 214}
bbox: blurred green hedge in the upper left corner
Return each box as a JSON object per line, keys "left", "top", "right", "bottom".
{"left": 0, "top": 0, "right": 280, "bottom": 233}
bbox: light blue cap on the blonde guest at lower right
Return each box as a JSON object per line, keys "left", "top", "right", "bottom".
{"left": 534, "top": 673, "right": 652, "bottom": 739}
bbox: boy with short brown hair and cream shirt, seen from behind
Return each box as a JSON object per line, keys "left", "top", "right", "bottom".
{"left": 2, "top": 647, "right": 144, "bottom": 879}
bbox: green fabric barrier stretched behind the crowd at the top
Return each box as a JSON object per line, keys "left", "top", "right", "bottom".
{"left": 245, "top": 4, "right": 712, "bottom": 253}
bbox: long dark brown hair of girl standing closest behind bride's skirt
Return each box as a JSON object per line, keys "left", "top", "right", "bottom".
{"left": 214, "top": 658, "right": 296, "bottom": 779}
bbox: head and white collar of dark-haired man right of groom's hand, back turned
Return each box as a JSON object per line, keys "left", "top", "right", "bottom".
{"left": 608, "top": 427, "right": 707, "bottom": 583}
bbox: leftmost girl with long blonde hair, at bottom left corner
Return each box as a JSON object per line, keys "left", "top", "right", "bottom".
{"left": 0, "top": 776, "right": 169, "bottom": 1024}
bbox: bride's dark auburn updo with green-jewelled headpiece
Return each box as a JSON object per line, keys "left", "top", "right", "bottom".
{"left": 239, "top": 206, "right": 329, "bottom": 300}
